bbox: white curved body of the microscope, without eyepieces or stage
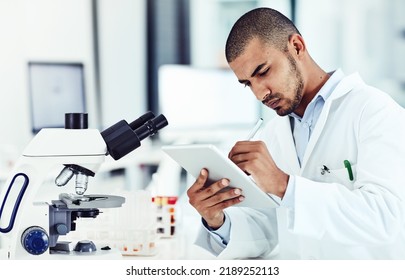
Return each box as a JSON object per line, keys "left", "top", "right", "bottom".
{"left": 0, "top": 129, "right": 113, "bottom": 259}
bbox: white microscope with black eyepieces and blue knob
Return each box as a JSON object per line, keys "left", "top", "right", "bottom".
{"left": 0, "top": 112, "right": 168, "bottom": 259}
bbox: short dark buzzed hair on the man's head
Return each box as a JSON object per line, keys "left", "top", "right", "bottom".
{"left": 225, "top": 8, "right": 300, "bottom": 62}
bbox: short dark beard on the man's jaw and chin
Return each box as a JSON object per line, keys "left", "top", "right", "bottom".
{"left": 262, "top": 53, "right": 304, "bottom": 116}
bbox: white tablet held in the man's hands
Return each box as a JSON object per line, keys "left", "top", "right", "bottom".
{"left": 162, "top": 144, "right": 279, "bottom": 208}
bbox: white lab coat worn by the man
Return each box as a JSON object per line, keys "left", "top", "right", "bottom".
{"left": 196, "top": 74, "right": 405, "bottom": 259}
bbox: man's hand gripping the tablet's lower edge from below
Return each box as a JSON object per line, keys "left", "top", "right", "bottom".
{"left": 187, "top": 169, "right": 244, "bottom": 229}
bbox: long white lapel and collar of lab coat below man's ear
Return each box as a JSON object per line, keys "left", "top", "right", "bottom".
{"left": 301, "top": 73, "right": 362, "bottom": 172}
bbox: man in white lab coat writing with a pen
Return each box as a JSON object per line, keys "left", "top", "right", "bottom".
{"left": 187, "top": 8, "right": 405, "bottom": 259}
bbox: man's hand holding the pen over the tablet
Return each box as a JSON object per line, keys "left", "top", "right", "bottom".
{"left": 228, "top": 141, "right": 289, "bottom": 198}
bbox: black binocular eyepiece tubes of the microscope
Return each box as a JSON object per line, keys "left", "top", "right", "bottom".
{"left": 101, "top": 112, "right": 168, "bottom": 160}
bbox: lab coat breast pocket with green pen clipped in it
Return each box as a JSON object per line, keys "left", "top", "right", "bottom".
{"left": 321, "top": 165, "right": 356, "bottom": 190}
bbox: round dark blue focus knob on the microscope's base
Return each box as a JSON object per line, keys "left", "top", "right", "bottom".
{"left": 21, "top": 226, "right": 49, "bottom": 255}
